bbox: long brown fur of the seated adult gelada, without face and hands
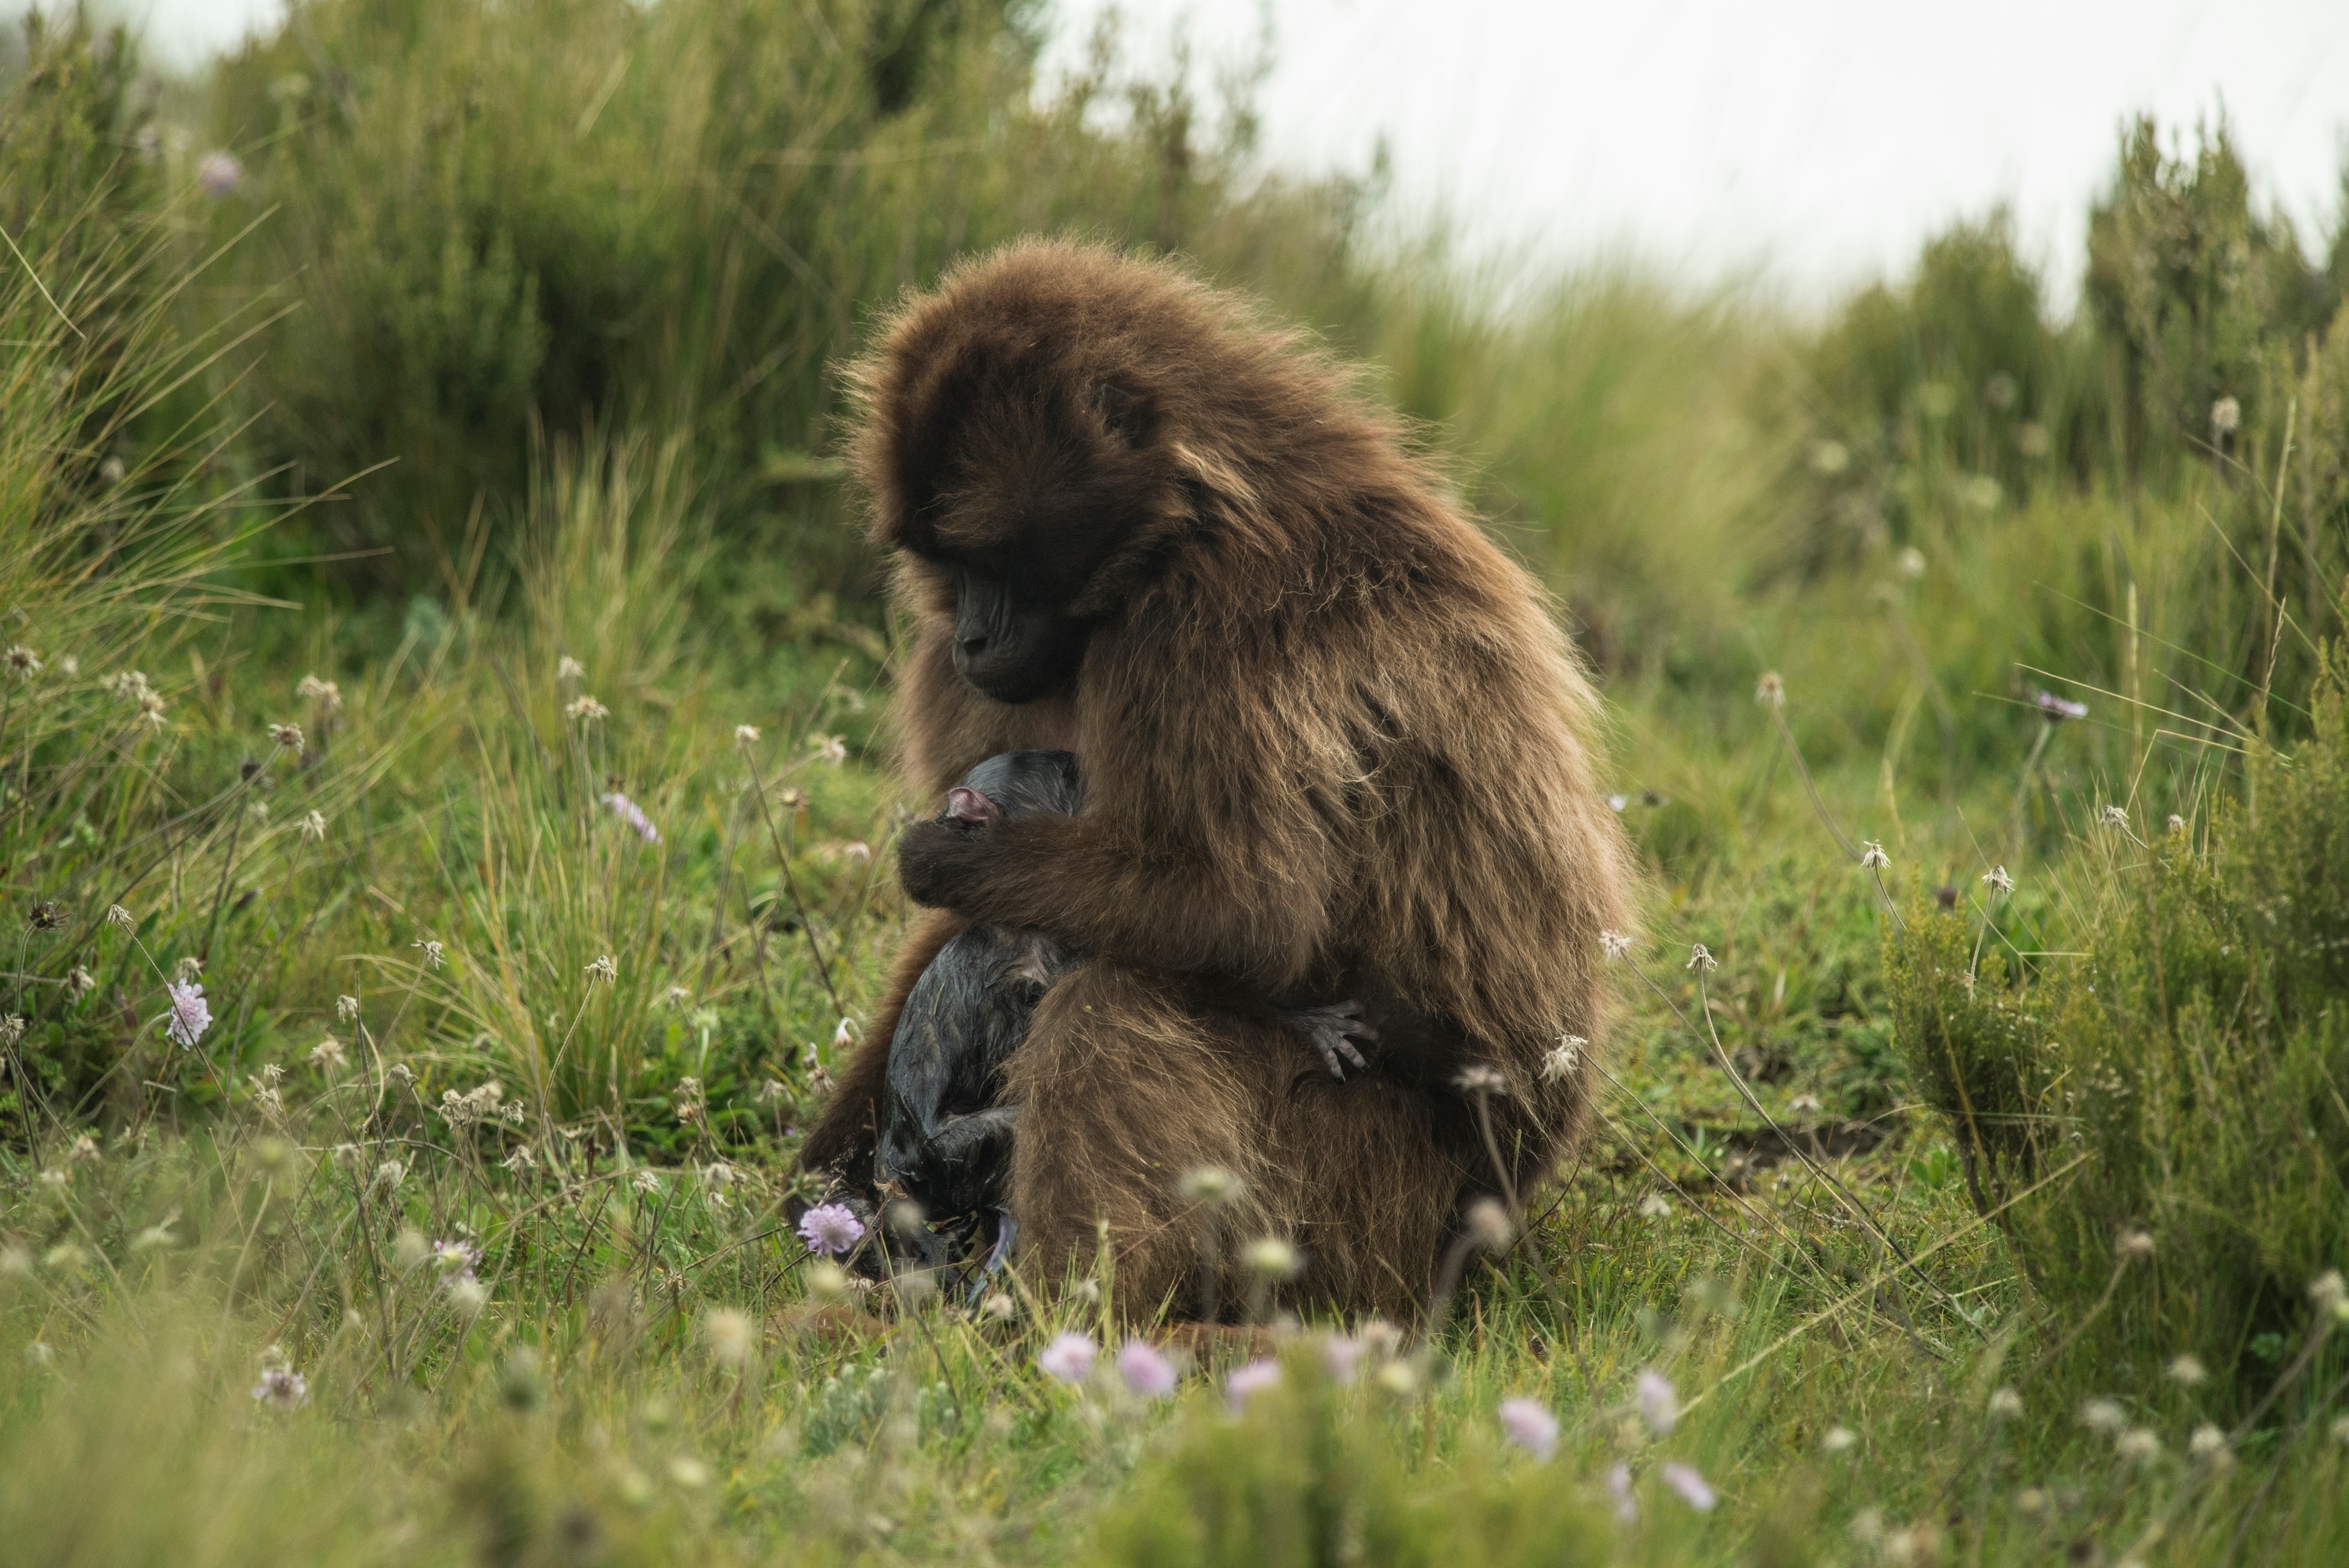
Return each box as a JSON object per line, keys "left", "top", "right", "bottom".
{"left": 806, "top": 242, "right": 1630, "bottom": 1316}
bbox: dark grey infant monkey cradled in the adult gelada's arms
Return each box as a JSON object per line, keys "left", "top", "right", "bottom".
{"left": 874, "top": 752, "right": 1379, "bottom": 1254}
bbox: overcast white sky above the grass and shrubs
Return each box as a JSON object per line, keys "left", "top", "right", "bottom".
{"left": 101, "top": 0, "right": 2349, "bottom": 303}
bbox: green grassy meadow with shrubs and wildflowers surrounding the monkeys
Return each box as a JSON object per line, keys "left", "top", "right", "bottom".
{"left": 0, "top": 0, "right": 2349, "bottom": 1568}
